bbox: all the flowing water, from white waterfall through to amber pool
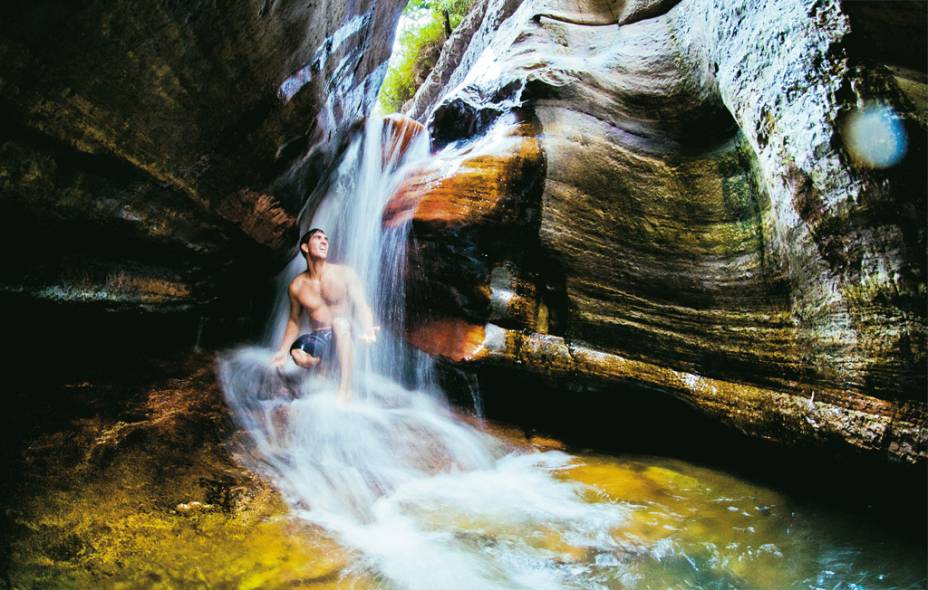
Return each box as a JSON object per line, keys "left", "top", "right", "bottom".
{"left": 214, "top": 117, "right": 924, "bottom": 590}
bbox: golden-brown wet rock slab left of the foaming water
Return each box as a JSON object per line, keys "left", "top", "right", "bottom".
{"left": 0, "top": 354, "right": 363, "bottom": 588}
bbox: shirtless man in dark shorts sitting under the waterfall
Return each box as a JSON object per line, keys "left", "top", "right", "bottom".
{"left": 271, "top": 228, "right": 378, "bottom": 401}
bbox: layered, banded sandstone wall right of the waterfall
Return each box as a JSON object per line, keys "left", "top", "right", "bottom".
{"left": 395, "top": 0, "right": 928, "bottom": 461}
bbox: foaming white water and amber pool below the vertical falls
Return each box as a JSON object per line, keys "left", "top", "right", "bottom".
{"left": 214, "top": 370, "right": 925, "bottom": 589}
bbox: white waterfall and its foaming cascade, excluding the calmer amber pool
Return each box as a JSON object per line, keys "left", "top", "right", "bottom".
{"left": 219, "top": 117, "right": 623, "bottom": 590}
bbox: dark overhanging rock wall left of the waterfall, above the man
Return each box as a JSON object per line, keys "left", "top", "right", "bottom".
{"left": 0, "top": 0, "right": 403, "bottom": 310}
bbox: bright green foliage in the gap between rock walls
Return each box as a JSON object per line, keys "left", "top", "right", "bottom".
{"left": 377, "top": 0, "right": 472, "bottom": 113}
